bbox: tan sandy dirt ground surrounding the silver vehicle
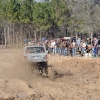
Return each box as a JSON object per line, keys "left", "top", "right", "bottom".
{"left": 0, "top": 50, "right": 100, "bottom": 100}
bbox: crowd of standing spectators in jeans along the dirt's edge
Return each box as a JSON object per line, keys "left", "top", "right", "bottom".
{"left": 26, "top": 37, "right": 99, "bottom": 57}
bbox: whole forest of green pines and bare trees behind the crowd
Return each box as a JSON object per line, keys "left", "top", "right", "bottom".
{"left": 0, "top": 0, "right": 100, "bottom": 47}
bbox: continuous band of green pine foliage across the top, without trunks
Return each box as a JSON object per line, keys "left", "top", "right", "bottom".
{"left": 0, "top": 0, "right": 70, "bottom": 30}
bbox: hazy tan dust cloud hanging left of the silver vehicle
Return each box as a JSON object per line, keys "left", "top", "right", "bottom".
{"left": 0, "top": 50, "right": 33, "bottom": 80}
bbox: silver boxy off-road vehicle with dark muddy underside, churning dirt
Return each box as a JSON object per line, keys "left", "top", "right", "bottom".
{"left": 24, "top": 45, "right": 48, "bottom": 74}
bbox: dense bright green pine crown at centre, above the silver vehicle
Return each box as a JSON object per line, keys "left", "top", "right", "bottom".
{"left": 33, "top": 2, "right": 53, "bottom": 29}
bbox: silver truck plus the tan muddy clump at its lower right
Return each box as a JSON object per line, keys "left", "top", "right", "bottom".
{"left": 24, "top": 45, "right": 56, "bottom": 80}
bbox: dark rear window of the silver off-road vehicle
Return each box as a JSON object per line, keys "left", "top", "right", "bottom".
{"left": 26, "top": 47, "right": 45, "bottom": 53}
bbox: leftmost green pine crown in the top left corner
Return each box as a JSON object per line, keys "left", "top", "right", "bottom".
{"left": 2, "top": 0, "right": 20, "bottom": 23}
